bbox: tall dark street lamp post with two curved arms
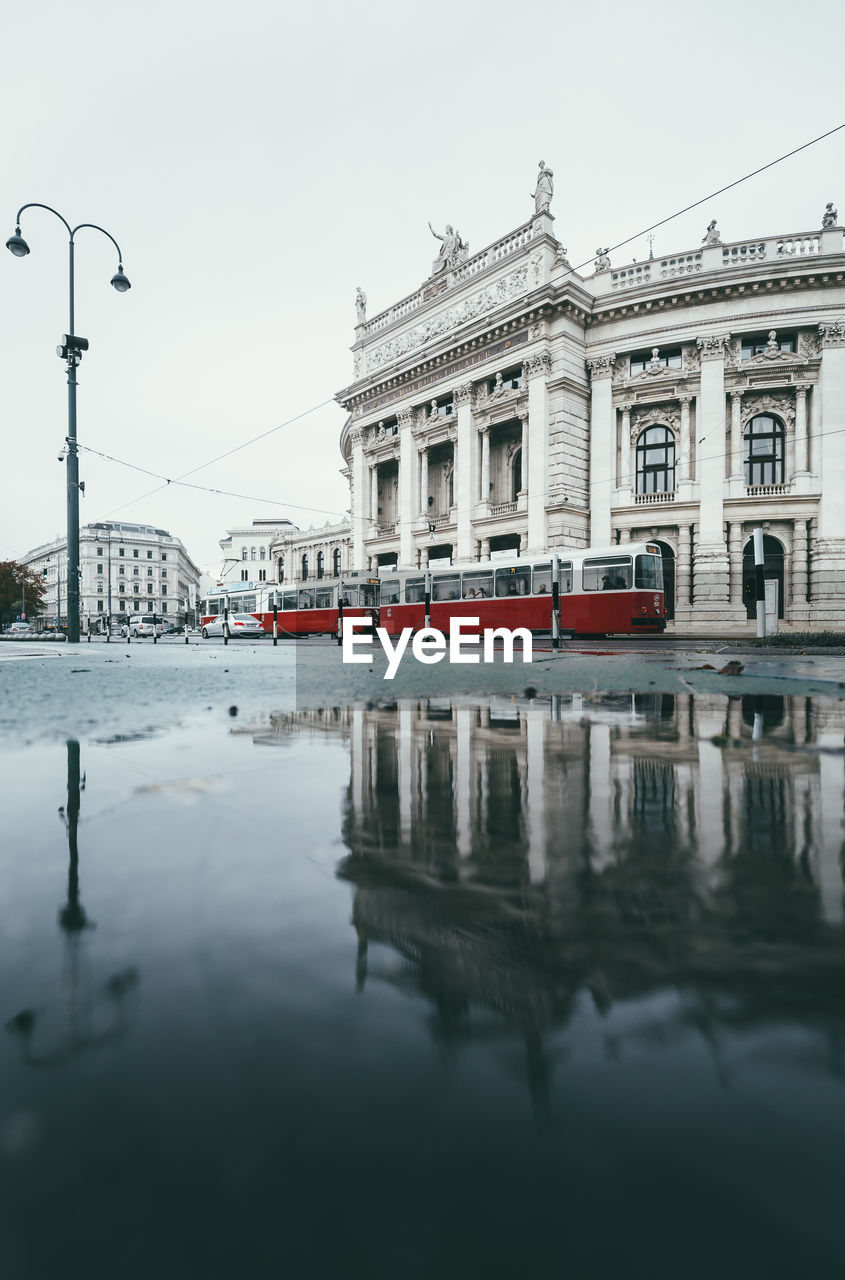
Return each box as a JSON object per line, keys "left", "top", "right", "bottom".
{"left": 6, "top": 201, "right": 131, "bottom": 644}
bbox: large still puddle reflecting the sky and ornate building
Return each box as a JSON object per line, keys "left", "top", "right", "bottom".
{"left": 0, "top": 695, "right": 845, "bottom": 1280}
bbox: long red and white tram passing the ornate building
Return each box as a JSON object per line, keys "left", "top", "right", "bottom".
{"left": 204, "top": 543, "right": 666, "bottom": 636}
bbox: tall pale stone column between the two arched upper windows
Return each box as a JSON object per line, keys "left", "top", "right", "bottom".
{"left": 693, "top": 334, "right": 730, "bottom": 626}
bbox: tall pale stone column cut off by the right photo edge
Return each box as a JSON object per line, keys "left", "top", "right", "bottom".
{"left": 812, "top": 320, "right": 845, "bottom": 627}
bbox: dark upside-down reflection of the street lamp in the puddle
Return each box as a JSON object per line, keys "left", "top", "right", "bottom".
{"left": 6, "top": 739, "right": 138, "bottom": 1066}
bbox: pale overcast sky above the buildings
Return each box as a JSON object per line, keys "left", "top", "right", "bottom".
{"left": 0, "top": 0, "right": 845, "bottom": 570}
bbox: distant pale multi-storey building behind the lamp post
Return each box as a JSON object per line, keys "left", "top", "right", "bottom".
{"left": 20, "top": 521, "right": 200, "bottom": 630}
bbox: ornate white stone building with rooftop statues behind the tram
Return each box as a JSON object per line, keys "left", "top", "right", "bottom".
{"left": 337, "top": 181, "right": 845, "bottom": 632}
